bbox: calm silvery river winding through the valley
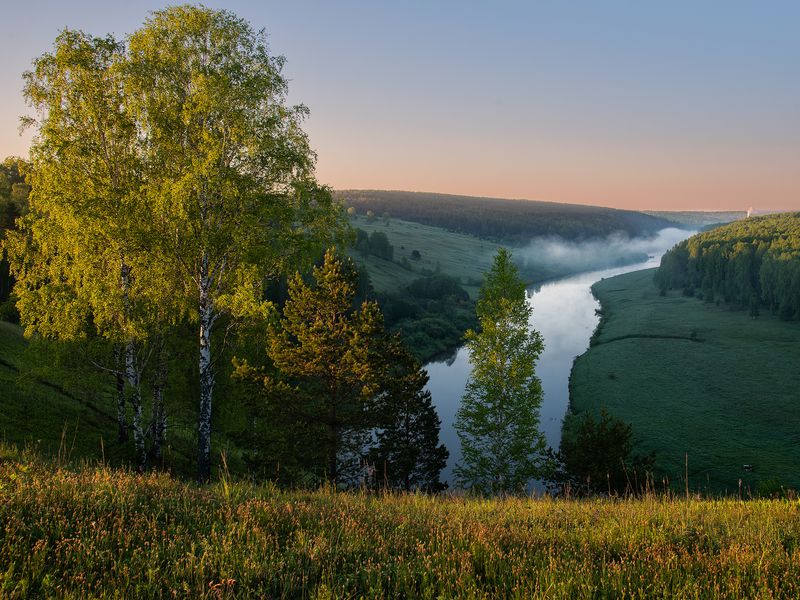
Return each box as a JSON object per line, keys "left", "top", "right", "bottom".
{"left": 425, "top": 229, "right": 692, "bottom": 488}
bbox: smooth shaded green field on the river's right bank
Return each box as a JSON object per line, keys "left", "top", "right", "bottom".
{"left": 565, "top": 270, "right": 800, "bottom": 494}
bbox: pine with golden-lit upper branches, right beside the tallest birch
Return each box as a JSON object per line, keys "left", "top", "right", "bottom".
{"left": 267, "top": 250, "right": 384, "bottom": 484}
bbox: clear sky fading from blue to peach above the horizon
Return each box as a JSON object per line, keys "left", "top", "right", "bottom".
{"left": 0, "top": 0, "right": 800, "bottom": 210}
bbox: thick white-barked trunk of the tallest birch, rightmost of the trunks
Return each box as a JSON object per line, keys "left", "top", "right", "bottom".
{"left": 197, "top": 254, "right": 214, "bottom": 483}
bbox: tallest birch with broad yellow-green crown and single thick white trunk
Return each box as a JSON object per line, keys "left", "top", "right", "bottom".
{"left": 126, "top": 5, "right": 339, "bottom": 482}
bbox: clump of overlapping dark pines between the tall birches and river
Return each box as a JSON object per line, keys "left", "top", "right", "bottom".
{"left": 238, "top": 250, "right": 447, "bottom": 491}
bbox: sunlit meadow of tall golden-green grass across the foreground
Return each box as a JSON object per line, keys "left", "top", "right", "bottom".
{"left": 0, "top": 457, "right": 800, "bottom": 598}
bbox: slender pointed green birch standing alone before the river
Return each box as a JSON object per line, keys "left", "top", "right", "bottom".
{"left": 455, "top": 248, "right": 546, "bottom": 494}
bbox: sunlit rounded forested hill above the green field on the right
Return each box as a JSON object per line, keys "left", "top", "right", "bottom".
{"left": 656, "top": 212, "right": 800, "bottom": 320}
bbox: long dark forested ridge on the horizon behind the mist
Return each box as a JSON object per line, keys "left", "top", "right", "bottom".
{"left": 336, "top": 190, "right": 678, "bottom": 244}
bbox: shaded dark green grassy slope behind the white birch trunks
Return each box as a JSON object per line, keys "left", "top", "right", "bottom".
{"left": 0, "top": 321, "right": 236, "bottom": 476}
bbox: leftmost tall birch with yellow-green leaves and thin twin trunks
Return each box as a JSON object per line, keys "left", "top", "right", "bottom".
{"left": 6, "top": 30, "right": 161, "bottom": 466}
